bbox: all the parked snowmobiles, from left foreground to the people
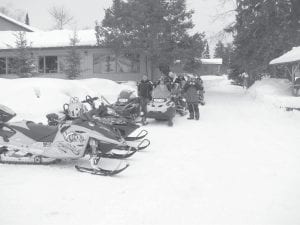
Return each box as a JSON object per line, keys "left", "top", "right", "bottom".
{"left": 0, "top": 79, "right": 204, "bottom": 175}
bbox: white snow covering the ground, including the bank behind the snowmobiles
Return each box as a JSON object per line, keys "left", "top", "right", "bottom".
{"left": 0, "top": 77, "right": 300, "bottom": 225}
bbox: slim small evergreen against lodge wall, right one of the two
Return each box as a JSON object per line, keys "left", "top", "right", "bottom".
{"left": 63, "top": 31, "right": 81, "bottom": 79}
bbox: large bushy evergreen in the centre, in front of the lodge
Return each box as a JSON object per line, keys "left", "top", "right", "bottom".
{"left": 96, "top": 0, "right": 203, "bottom": 76}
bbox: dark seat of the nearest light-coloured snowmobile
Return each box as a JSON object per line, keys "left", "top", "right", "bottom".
{"left": 12, "top": 121, "right": 58, "bottom": 142}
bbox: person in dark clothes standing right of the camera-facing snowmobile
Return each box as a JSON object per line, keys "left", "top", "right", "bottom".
{"left": 183, "top": 78, "right": 201, "bottom": 120}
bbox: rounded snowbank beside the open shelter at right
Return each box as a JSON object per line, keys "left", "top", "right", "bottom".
{"left": 248, "top": 78, "right": 300, "bottom": 108}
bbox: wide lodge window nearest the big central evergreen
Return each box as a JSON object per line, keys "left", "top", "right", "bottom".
{"left": 93, "top": 54, "right": 140, "bottom": 73}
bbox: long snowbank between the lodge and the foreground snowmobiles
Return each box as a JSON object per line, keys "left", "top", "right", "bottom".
{"left": 0, "top": 78, "right": 134, "bottom": 122}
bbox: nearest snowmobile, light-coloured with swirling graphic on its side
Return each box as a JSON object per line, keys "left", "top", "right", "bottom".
{"left": 0, "top": 105, "right": 148, "bottom": 175}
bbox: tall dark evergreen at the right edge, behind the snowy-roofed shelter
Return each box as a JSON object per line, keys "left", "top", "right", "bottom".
{"left": 228, "top": 0, "right": 300, "bottom": 81}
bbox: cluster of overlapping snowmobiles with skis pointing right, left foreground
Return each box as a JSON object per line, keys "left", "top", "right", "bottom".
{"left": 0, "top": 96, "right": 150, "bottom": 175}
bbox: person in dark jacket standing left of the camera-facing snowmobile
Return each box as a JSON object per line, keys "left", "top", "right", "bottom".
{"left": 138, "top": 75, "right": 153, "bottom": 124}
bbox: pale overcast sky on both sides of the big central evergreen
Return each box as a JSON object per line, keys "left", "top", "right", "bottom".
{"left": 0, "top": 0, "right": 236, "bottom": 42}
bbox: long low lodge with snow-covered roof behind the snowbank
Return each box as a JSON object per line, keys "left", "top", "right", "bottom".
{"left": 0, "top": 13, "right": 220, "bottom": 81}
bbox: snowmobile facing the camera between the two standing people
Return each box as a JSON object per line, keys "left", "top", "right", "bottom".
{"left": 147, "top": 82, "right": 176, "bottom": 126}
